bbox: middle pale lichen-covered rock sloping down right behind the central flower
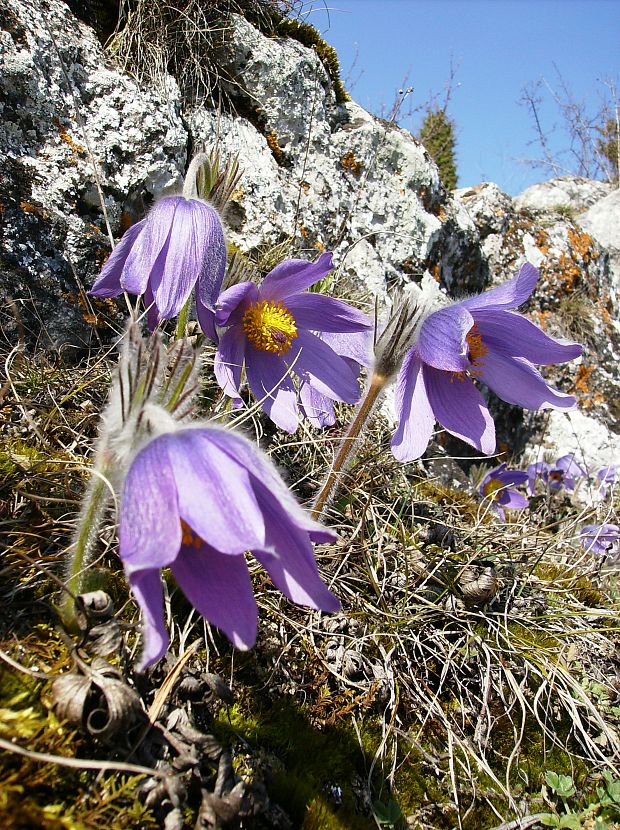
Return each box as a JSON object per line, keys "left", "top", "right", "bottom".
{"left": 189, "top": 16, "right": 482, "bottom": 293}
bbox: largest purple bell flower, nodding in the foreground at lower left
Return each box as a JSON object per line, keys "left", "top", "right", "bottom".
{"left": 119, "top": 425, "right": 340, "bottom": 669}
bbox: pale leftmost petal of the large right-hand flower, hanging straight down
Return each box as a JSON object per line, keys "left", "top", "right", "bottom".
{"left": 392, "top": 349, "right": 435, "bottom": 462}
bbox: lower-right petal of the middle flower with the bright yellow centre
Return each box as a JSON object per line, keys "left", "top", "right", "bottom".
{"left": 284, "top": 331, "right": 360, "bottom": 403}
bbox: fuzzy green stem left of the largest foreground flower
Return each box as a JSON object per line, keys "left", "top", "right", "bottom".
{"left": 60, "top": 458, "right": 110, "bottom": 629}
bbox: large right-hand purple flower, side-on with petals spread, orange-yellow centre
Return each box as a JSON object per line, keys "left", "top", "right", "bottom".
{"left": 392, "top": 263, "right": 581, "bottom": 461}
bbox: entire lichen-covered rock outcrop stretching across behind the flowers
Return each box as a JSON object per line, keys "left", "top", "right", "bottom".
{"left": 0, "top": 0, "right": 620, "bottom": 472}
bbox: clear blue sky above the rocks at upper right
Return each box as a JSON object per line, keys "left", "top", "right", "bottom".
{"left": 305, "top": 0, "right": 620, "bottom": 195}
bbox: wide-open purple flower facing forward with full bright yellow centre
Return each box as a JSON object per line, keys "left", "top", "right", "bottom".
{"left": 208, "top": 253, "right": 371, "bottom": 432}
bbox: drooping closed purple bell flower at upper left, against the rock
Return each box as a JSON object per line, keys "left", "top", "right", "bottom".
{"left": 89, "top": 196, "right": 226, "bottom": 331}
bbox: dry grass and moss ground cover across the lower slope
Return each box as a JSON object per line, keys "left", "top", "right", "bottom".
{"left": 0, "top": 290, "right": 620, "bottom": 828}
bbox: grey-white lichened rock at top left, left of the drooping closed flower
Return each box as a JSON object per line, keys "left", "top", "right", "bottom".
{"left": 0, "top": 0, "right": 187, "bottom": 347}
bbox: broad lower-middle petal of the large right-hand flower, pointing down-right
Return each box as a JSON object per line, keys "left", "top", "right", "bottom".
{"left": 423, "top": 366, "right": 495, "bottom": 455}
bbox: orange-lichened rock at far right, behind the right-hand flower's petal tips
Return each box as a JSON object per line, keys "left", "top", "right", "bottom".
{"left": 455, "top": 177, "right": 620, "bottom": 469}
